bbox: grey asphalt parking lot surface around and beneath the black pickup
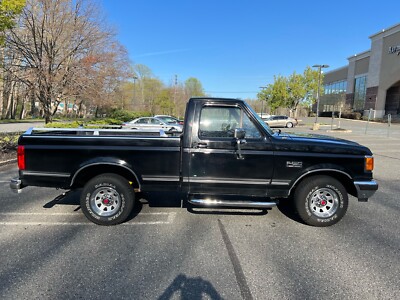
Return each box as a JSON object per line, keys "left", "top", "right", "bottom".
{"left": 0, "top": 118, "right": 400, "bottom": 299}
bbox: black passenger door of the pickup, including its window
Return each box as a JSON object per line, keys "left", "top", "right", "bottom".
{"left": 185, "top": 105, "right": 273, "bottom": 196}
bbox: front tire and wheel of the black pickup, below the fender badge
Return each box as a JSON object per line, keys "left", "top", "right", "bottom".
{"left": 294, "top": 176, "right": 349, "bottom": 227}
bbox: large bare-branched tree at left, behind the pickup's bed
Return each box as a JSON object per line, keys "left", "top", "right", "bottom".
{"left": 6, "top": 0, "right": 125, "bottom": 123}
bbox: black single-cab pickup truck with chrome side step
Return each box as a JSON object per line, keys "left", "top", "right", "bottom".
{"left": 10, "top": 98, "right": 378, "bottom": 226}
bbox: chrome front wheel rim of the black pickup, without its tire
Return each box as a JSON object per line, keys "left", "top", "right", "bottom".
{"left": 308, "top": 188, "right": 339, "bottom": 218}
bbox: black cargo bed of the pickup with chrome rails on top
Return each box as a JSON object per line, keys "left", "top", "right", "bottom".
{"left": 19, "top": 128, "right": 180, "bottom": 189}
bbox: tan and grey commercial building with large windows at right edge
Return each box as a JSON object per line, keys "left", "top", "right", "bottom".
{"left": 320, "top": 24, "right": 400, "bottom": 118}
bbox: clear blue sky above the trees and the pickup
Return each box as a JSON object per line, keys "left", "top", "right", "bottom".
{"left": 98, "top": 0, "right": 400, "bottom": 99}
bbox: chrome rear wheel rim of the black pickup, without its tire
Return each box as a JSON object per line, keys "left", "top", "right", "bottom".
{"left": 90, "top": 187, "right": 122, "bottom": 217}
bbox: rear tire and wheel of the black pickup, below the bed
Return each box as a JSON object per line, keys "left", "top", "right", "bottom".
{"left": 80, "top": 173, "right": 135, "bottom": 225}
